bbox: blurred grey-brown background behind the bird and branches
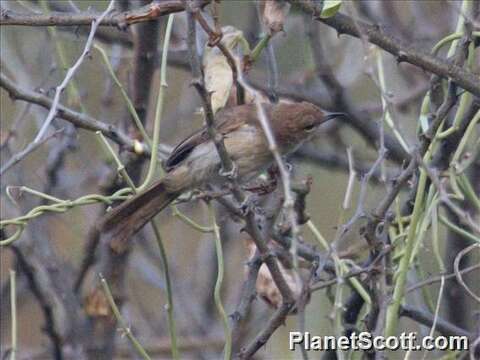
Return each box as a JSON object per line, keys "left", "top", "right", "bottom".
{"left": 0, "top": 0, "right": 480, "bottom": 359}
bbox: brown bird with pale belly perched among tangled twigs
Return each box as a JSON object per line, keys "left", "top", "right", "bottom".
{"left": 100, "top": 102, "right": 343, "bottom": 245}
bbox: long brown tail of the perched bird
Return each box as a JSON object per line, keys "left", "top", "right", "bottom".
{"left": 99, "top": 180, "right": 179, "bottom": 245}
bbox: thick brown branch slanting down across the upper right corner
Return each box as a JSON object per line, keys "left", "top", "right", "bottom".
{"left": 289, "top": 0, "right": 480, "bottom": 96}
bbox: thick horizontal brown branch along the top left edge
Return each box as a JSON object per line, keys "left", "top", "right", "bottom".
{"left": 0, "top": 0, "right": 210, "bottom": 28}
